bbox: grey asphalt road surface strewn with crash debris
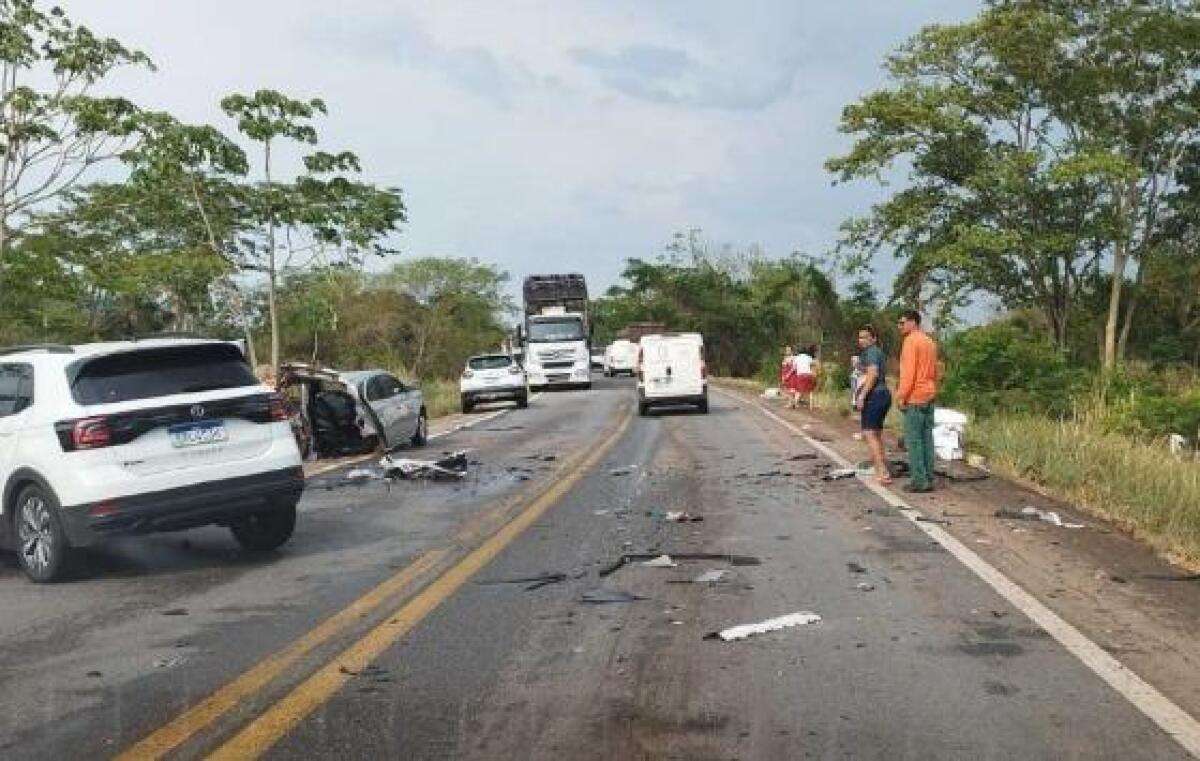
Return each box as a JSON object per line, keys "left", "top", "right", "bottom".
{"left": 0, "top": 381, "right": 1187, "bottom": 760}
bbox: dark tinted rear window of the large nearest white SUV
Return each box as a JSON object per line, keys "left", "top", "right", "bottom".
{"left": 71, "top": 343, "right": 258, "bottom": 405}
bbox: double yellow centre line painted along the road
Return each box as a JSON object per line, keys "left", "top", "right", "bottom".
{"left": 116, "top": 407, "right": 632, "bottom": 761}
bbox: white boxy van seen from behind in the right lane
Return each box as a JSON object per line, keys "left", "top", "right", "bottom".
{"left": 637, "top": 332, "right": 708, "bottom": 415}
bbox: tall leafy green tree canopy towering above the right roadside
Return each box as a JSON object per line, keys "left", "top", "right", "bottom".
{"left": 828, "top": 0, "right": 1200, "bottom": 367}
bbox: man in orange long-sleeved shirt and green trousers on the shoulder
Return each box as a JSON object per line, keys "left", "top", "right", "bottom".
{"left": 896, "top": 310, "right": 937, "bottom": 492}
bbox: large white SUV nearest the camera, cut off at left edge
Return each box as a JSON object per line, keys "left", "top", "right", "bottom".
{"left": 0, "top": 338, "right": 304, "bottom": 581}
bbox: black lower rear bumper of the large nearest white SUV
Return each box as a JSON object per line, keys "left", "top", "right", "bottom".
{"left": 61, "top": 467, "right": 304, "bottom": 546}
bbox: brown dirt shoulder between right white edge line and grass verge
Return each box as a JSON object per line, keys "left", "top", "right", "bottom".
{"left": 721, "top": 379, "right": 1200, "bottom": 729}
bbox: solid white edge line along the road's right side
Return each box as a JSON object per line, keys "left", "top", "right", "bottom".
{"left": 719, "top": 391, "right": 1200, "bottom": 759}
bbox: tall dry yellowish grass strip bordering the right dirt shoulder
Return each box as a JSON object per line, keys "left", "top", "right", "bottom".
{"left": 967, "top": 415, "right": 1200, "bottom": 565}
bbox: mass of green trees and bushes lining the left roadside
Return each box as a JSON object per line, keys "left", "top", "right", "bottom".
{"left": 0, "top": 0, "right": 510, "bottom": 412}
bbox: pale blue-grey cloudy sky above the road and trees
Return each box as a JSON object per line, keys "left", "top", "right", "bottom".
{"left": 62, "top": 0, "right": 980, "bottom": 292}
